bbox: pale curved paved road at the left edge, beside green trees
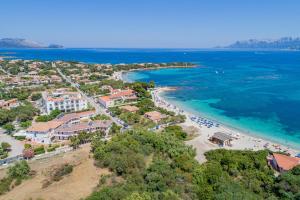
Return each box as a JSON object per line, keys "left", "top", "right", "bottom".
{"left": 0, "top": 129, "right": 24, "bottom": 158}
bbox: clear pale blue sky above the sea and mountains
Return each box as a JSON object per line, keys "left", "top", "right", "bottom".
{"left": 0, "top": 0, "right": 300, "bottom": 48}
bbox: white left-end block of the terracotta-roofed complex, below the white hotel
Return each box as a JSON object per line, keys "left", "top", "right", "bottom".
{"left": 26, "top": 121, "right": 63, "bottom": 144}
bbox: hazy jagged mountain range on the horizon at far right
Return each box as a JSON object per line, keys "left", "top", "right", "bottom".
{"left": 225, "top": 37, "right": 300, "bottom": 50}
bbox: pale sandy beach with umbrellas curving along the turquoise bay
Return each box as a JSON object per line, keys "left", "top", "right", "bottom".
{"left": 118, "top": 69, "right": 299, "bottom": 162}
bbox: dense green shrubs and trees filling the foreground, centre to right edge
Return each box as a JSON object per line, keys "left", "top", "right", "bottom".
{"left": 88, "top": 130, "right": 300, "bottom": 200}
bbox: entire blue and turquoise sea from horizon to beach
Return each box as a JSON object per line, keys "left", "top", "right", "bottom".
{"left": 0, "top": 49, "right": 300, "bottom": 149}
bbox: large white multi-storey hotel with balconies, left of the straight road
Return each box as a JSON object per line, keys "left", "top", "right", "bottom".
{"left": 42, "top": 89, "right": 88, "bottom": 114}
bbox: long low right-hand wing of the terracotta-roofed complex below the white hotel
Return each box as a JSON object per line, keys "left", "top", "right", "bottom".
{"left": 54, "top": 120, "right": 112, "bottom": 140}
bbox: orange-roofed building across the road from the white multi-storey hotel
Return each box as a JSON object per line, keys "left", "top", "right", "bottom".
{"left": 99, "top": 89, "right": 137, "bottom": 108}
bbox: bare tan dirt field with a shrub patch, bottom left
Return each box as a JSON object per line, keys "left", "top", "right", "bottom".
{"left": 0, "top": 145, "right": 109, "bottom": 200}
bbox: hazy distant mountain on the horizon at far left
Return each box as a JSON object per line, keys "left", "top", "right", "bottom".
{"left": 0, "top": 38, "right": 63, "bottom": 48}
